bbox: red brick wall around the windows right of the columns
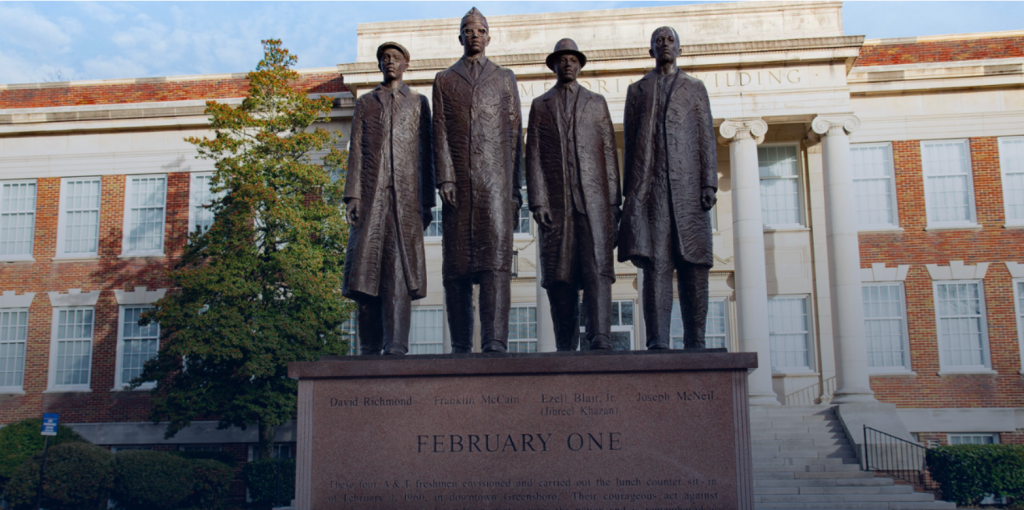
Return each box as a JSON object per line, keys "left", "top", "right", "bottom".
{"left": 860, "top": 137, "right": 1024, "bottom": 408}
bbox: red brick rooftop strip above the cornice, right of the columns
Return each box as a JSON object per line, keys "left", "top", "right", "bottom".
{"left": 857, "top": 37, "right": 1024, "bottom": 68}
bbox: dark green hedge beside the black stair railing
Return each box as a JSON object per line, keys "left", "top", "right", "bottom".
{"left": 928, "top": 444, "right": 1024, "bottom": 505}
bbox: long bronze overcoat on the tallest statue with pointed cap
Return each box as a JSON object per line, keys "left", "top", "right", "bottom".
{"left": 433, "top": 59, "right": 522, "bottom": 281}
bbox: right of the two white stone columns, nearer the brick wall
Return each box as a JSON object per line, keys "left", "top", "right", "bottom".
{"left": 811, "top": 114, "right": 876, "bottom": 403}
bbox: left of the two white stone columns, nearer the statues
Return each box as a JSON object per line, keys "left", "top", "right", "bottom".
{"left": 719, "top": 119, "right": 779, "bottom": 406}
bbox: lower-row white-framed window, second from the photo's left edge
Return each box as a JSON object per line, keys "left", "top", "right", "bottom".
{"left": 50, "top": 306, "right": 95, "bottom": 390}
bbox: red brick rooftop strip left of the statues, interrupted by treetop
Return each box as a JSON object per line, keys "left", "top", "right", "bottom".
{"left": 0, "top": 73, "right": 348, "bottom": 109}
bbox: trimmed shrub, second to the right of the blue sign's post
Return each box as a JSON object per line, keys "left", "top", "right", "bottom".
{"left": 111, "top": 450, "right": 195, "bottom": 510}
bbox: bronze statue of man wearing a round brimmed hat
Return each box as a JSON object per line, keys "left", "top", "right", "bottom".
{"left": 526, "top": 39, "right": 622, "bottom": 350}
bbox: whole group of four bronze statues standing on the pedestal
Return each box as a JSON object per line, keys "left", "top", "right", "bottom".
{"left": 343, "top": 7, "right": 718, "bottom": 355}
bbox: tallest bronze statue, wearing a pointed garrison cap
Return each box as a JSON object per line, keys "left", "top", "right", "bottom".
{"left": 434, "top": 7, "right": 522, "bottom": 352}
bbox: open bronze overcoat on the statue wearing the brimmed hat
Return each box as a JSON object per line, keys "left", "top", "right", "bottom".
{"left": 526, "top": 87, "right": 622, "bottom": 288}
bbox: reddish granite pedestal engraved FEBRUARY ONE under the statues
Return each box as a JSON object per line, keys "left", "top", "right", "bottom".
{"left": 289, "top": 349, "right": 757, "bottom": 510}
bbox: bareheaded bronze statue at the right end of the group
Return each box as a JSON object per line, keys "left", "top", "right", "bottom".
{"left": 618, "top": 27, "right": 718, "bottom": 349}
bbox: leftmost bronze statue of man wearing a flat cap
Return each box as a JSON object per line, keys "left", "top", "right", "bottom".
{"left": 342, "top": 42, "right": 434, "bottom": 354}
